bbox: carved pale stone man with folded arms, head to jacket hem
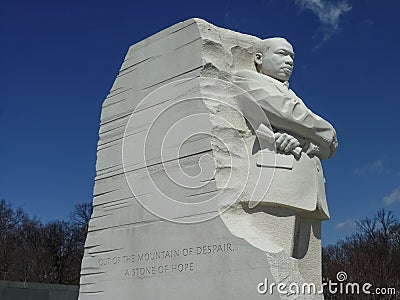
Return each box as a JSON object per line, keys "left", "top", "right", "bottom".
{"left": 234, "top": 38, "right": 338, "bottom": 252}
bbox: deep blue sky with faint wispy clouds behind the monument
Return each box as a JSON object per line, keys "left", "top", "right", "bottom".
{"left": 0, "top": 0, "right": 400, "bottom": 245}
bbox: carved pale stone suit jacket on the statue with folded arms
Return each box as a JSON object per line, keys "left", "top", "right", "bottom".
{"left": 233, "top": 70, "right": 338, "bottom": 219}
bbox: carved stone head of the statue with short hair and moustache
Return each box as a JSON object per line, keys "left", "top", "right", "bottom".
{"left": 254, "top": 37, "right": 294, "bottom": 82}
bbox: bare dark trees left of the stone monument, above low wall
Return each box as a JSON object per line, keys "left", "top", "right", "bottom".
{"left": 0, "top": 200, "right": 92, "bottom": 284}
